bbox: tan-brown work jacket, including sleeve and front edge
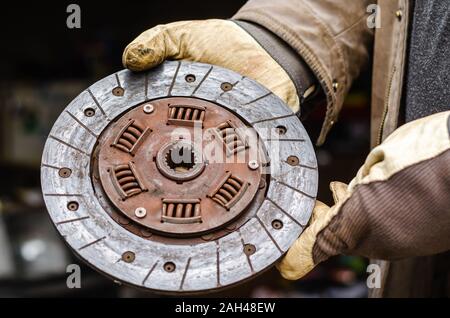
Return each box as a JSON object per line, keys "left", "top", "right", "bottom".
{"left": 234, "top": 0, "right": 444, "bottom": 297}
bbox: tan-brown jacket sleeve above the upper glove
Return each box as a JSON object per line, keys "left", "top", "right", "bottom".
{"left": 233, "top": 0, "right": 374, "bottom": 144}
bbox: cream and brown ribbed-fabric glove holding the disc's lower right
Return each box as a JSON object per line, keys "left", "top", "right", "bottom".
{"left": 277, "top": 111, "right": 450, "bottom": 279}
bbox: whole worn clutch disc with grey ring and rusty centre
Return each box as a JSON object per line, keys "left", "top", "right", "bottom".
{"left": 41, "top": 62, "right": 318, "bottom": 293}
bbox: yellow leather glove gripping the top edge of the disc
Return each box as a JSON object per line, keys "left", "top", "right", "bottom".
{"left": 122, "top": 20, "right": 299, "bottom": 111}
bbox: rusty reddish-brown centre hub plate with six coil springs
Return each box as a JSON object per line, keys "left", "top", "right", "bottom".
{"left": 97, "top": 97, "right": 263, "bottom": 237}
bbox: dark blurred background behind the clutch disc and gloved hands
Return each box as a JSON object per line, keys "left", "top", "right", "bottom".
{"left": 0, "top": 0, "right": 371, "bottom": 297}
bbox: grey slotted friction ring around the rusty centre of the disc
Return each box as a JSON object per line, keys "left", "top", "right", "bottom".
{"left": 41, "top": 62, "right": 318, "bottom": 293}
